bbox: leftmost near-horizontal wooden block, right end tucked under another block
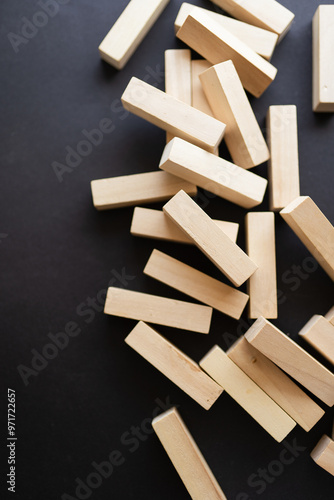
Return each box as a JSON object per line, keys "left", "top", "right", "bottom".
{"left": 91, "top": 171, "right": 197, "bottom": 210}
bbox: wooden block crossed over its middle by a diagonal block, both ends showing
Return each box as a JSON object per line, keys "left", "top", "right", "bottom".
{"left": 130, "top": 207, "right": 239, "bottom": 245}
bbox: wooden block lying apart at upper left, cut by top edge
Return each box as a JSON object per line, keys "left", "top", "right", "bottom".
{"left": 99, "top": 0, "right": 169, "bottom": 69}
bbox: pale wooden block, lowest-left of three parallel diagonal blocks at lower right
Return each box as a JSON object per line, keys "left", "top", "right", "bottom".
{"left": 199, "top": 345, "right": 296, "bottom": 443}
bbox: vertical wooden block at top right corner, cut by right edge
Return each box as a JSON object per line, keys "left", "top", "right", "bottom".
{"left": 312, "top": 5, "right": 334, "bottom": 113}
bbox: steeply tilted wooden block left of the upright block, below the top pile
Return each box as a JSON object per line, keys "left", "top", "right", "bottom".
{"left": 200, "top": 61, "right": 269, "bottom": 169}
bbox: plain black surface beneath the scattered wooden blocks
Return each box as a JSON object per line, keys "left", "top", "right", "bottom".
{"left": 0, "top": 0, "right": 334, "bottom": 500}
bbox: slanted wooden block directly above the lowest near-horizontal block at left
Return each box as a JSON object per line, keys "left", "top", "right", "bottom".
{"left": 144, "top": 250, "right": 248, "bottom": 319}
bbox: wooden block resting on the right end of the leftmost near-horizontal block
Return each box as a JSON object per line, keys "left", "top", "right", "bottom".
{"left": 160, "top": 138, "right": 267, "bottom": 208}
